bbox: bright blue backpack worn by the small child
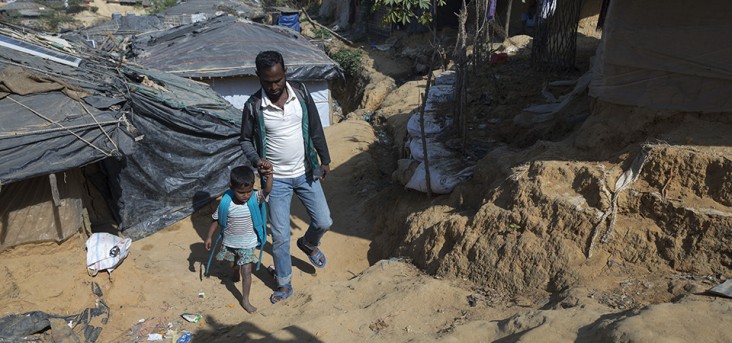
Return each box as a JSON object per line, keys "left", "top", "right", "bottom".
{"left": 206, "top": 189, "right": 267, "bottom": 275}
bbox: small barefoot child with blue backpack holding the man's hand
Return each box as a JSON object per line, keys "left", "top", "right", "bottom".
{"left": 205, "top": 161, "right": 272, "bottom": 313}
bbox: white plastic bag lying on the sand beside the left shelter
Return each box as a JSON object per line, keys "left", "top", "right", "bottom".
{"left": 86, "top": 232, "right": 132, "bottom": 276}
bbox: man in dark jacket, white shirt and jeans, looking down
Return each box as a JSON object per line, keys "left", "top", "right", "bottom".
{"left": 239, "top": 51, "right": 333, "bottom": 303}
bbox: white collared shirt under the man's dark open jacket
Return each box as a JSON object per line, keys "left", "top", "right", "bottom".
{"left": 262, "top": 83, "right": 306, "bottom": 178}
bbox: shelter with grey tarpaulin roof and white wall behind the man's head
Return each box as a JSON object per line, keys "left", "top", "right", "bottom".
{"left": 128, "top": 16, "right": 343, "bottom": 127}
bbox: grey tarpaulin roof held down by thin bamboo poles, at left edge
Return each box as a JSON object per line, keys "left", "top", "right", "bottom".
{"left": 0, "top": 32, "right": 132, "bottom": 185}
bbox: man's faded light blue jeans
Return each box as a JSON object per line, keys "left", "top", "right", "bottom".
{"left": 268, "top": 173, "right": 333, "bottom": 286}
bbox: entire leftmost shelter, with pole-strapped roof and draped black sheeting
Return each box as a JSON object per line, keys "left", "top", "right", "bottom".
{"left": 0, "top": 22, "right": 246, "bottom": 246}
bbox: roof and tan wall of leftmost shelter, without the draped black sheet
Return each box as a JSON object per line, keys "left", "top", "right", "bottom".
{"left": 0, "top": 26, "right": 132, "bottom": 250}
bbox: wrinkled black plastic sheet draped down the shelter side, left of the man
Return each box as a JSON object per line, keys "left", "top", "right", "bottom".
{"left": 104, "top": 67, "right": 248, "bottom": 240}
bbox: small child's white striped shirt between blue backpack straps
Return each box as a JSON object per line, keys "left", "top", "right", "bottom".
{"left": 211, "top": 191, "right": 265, "bottom": 249}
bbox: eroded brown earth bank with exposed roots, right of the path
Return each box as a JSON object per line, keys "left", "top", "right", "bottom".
{"left": 370, "top": 45, "right": 732, "bottom": 342}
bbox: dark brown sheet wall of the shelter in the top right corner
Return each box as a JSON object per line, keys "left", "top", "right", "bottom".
{"left": 590, "top": 0, "right": 732, "bottom": 112}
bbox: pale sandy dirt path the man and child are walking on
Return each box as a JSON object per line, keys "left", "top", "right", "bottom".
{"left": 0, "top": 114, "right": 732, "bottom": 342}
